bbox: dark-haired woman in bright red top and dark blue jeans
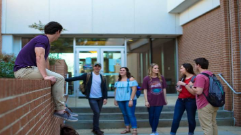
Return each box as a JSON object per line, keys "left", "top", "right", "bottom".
{"left": 170, "top": 63, "right": 197, "bottom": 135}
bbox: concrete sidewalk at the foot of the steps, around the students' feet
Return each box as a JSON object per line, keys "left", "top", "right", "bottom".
{"left": 77, "top": 126, "right": 241, "bottom": 135}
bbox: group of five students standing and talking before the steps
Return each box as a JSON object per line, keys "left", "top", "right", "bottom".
{"left": 65, "top": 58, "right": 218, "bottom": 135}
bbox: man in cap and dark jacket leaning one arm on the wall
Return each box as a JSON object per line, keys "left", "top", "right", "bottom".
{"left": 65, "top": 63, "right": 107, "bottom": 135}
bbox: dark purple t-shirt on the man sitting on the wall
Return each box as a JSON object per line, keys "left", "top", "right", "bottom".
{"left": 14, "top": 35, "right": 50, "bottom": 72}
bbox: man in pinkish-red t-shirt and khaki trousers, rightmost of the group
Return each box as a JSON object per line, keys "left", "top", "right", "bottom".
{"left": 189, "top": 58, "right": 218, "bottom": 135}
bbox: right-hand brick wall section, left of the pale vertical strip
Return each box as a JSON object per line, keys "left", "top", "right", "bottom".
{"left": 178, "top": 1, "right": 233, "bottom": 110}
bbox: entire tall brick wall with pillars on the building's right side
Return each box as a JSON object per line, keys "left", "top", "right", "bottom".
{"left": 178, "top": 0, "right": 241, "bottom": 126}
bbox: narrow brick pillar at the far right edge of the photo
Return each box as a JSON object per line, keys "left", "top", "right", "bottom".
{"left": 229, "top": 0, "right": 241, "bottom": 126}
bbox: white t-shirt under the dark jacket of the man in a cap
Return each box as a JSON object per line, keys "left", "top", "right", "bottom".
{"left": 90, "top": 72, "right": 102, "bottom": 98}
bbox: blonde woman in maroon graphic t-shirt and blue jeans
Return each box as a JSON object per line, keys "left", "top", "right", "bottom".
{"left": 142, "top": 63, "right": 167, "bottom": 135}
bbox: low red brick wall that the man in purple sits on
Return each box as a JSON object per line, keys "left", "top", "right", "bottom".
{"left": 0, "top": 79, "right": 63, "bottom": 135}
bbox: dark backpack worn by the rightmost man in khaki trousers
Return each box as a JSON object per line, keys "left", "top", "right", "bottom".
{"left": 201, "top": 73, "right": 225, "bottom": 107}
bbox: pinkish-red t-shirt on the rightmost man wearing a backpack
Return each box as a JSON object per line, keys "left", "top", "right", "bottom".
{"left": 193, "top": 70, "right": 212, "bottom": 109}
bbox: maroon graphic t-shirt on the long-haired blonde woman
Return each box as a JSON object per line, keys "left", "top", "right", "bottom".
{"left": 142, "top": 76, "right": 167, "bottom": 106}
